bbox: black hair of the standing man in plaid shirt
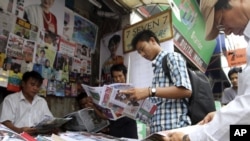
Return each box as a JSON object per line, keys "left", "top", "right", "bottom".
{"left": 131, "top": 30, "right": 160, "bottom": 49}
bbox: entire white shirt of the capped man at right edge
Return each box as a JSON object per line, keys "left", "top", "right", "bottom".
{"left": 189, "top": 21, "right": 250, "bottom": 141}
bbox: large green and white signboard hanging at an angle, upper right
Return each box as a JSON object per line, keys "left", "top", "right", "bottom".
{"left": 170, "top": 0, "right": 216, "bottom": 72}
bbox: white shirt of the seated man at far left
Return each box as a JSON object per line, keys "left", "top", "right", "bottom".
{"left": 0, "top": 91, "right": 53, "bottom": 128}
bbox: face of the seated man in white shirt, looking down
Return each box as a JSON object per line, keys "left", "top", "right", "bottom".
{"left": 22, "top": 78, "right": 41, "bottom": 97}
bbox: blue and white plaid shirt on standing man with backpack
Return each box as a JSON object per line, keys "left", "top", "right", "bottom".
{"left": 150, "top": 51, "right": 192, "bottom": 133}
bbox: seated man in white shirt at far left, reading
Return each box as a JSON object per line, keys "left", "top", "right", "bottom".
{"left": 0, "top": 71, "right": 53, "bottom": 134}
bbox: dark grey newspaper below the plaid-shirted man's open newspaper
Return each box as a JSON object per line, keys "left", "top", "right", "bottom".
{"left": 64, "top": 108, "right": 109, "bottom": 132}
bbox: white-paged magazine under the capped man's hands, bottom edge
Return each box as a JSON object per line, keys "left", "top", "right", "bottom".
{"left": 142, "top": 125, "right": 201, "bottom": 141}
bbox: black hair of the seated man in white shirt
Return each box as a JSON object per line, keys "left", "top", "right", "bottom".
{"left": 22, "top": 71, "right": 43, "bottom": 84}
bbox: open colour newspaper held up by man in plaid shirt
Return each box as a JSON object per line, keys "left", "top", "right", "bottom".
{"left": 82, "top": 83, "right": 157, "bottom": 123}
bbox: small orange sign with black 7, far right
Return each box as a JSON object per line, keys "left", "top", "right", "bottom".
{"left": 227, "top": 48, "right": 247, "bottom": 67}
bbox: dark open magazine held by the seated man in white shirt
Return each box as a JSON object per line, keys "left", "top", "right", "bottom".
{"left": 35, "top": 117, "right": 72, "bottom": 133}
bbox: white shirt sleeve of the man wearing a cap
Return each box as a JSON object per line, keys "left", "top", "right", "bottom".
{"left": 189, "top": 93, "right": 250, "bottom": 141}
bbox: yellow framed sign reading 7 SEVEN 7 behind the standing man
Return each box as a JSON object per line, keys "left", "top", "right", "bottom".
{"left": 123, "top": 10, "right": 173, "bottom": 53}
